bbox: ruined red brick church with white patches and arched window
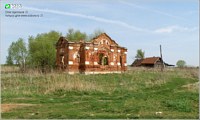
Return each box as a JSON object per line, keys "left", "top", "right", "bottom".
{"left": 56, "top": 33, "right": 127, "bottom": 74}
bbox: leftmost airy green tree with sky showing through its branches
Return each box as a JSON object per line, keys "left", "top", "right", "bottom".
{"left": 6, "top": 38, "right": 28, "bottom": 71}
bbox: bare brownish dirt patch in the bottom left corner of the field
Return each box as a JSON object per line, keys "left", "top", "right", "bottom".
{"left": 1, "top": 104, "right": 35, "bottom": 113}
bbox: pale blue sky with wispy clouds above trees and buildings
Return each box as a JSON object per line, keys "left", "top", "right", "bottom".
{"left": 1, "top": 0, "right": 199, "bottom": 66}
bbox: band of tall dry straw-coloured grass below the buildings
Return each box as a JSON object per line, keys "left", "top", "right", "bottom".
{"left": 1, "top": 67, "right": 198, "bottom": 95}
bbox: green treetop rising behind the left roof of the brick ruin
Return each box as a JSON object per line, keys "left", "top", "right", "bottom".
{"left": 66, "top": 28, "right": 87, "bottom": 42}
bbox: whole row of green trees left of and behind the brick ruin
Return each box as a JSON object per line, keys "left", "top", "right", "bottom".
{"left": 6, "top": 28, "right": 103, "bottom": 72}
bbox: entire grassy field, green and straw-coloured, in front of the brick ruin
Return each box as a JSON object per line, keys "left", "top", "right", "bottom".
{"left": 1, "top": 67, "right": 199, "bottom": 119}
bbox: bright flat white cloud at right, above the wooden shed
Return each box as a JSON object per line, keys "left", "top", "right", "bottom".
{"left": 154, "top": 25, "right": 198, "bottom": 33}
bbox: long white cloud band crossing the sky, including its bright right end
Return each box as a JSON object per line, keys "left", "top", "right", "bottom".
{"left": 24, "top": 6, "right": 198, "bottom": 33}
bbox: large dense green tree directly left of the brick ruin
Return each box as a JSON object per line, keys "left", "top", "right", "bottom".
{"left": 28, "top": 31, "right": 61, "bottom": 72}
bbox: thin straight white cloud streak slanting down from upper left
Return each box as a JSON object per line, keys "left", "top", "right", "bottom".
{"left": 24, "top": 7, "right": 149, "bottom": 32}
